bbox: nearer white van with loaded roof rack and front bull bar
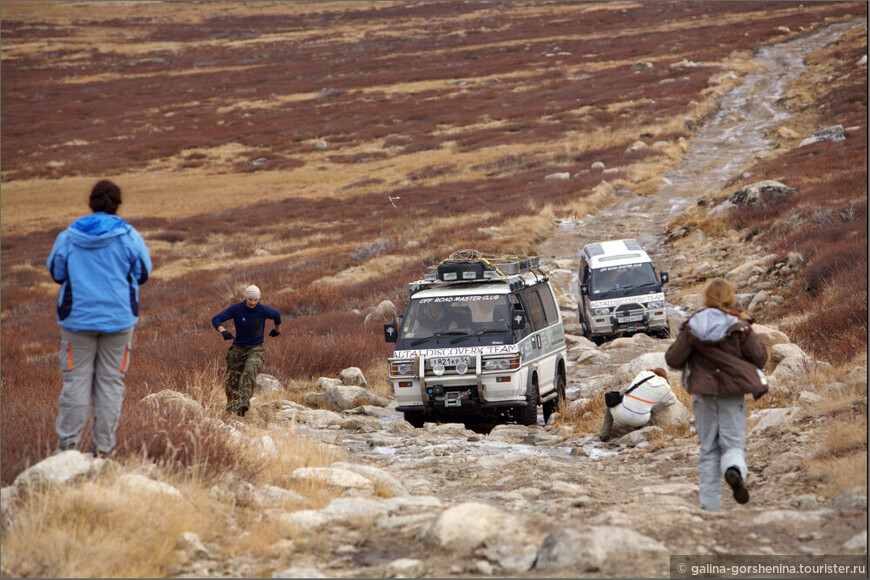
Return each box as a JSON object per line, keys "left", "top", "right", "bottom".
{"left": 384, "top": 258, "right": 567, "bottom": 427}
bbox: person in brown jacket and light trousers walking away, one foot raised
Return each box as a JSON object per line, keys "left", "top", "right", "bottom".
{"left": 665, "top": 278, "right": 767, "bottom": 511}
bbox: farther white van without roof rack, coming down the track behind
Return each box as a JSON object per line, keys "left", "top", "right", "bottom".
{"left": 577, "top": 240, "right": 670, "bottom": 344}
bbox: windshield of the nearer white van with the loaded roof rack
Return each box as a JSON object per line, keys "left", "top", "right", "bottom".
{"left": 396, "top": 294, "right": 511, "bottom": 350}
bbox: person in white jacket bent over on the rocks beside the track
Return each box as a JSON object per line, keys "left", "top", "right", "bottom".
{"left": 601, "top": 368, "right": 677, "bottom": 441}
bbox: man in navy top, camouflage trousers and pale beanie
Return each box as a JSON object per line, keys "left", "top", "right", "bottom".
{"left": 211, "top": 285, "right": 281, "bottom": 417}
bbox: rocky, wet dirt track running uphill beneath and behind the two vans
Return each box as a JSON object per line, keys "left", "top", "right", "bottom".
{"left": 188, "top": 20, "right": 866, "bottom": 577}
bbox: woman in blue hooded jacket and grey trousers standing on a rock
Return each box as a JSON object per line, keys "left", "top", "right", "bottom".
{"left": 46, "top": 180, "right": 151, "bottom": 456}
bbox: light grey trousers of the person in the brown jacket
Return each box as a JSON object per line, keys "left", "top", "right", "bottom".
{"left": 692, "top": 395, "right": 748, "bottom": 512}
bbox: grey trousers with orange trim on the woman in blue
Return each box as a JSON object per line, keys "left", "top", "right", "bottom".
{"left": 55, "top": 328, "right": 133, "bottom": 453}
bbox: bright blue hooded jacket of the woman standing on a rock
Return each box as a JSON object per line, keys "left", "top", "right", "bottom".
{"left": 46, "top": 212, "right": 151, "bottom": 332}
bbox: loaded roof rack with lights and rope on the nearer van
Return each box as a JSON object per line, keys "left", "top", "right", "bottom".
{"left": 410, "top": 250, "right": 547, "bottom": 294}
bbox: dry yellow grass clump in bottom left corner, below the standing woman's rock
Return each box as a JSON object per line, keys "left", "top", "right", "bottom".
{"left": 2, "top": 479, "right": 220, "bottom": 578}
